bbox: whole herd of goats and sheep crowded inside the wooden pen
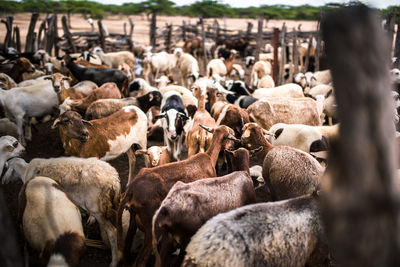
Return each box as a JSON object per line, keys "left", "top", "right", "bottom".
{"left": 0, "top": 11, "right": 400, "bottom": 266}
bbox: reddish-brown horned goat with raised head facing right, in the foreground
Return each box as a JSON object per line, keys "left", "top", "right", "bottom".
{"left": 117, "top": 125, "right": 238, "bottom": 266}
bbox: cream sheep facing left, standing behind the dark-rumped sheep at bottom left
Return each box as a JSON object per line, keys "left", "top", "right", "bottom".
{"left": 2, "top": 157, "right": 121, "bottom": 266}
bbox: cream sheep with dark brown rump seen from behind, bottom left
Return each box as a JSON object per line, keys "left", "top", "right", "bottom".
{"left": 18, "top": 176, "right": 86, "bottom": 267}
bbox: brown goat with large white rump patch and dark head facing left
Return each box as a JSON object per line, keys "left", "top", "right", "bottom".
{"left": 52, "top": 106, "right": 147, "bottom": 180}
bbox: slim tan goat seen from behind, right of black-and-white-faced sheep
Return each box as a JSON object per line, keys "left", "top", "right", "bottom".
{"left": 186, "top": 85, "right": 216, "bottom": 157}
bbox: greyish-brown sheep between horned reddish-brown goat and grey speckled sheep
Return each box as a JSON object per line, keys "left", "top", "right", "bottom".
{"left": 153, "top": 148, "right": 256, "bottom": 266}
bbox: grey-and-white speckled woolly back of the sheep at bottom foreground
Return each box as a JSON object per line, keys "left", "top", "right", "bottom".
{"left": 182, "top": 195, "right": 328, "bottom": 267}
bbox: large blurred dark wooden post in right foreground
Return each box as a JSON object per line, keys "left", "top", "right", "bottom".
{"left": 321, "top": 5, "right": 400, "bottom": 266}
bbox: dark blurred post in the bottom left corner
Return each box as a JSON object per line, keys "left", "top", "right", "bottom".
{"left": 0, "top": 188, "right": 24, "bottom": 267}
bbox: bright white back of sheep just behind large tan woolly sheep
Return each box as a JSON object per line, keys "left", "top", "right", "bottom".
{"left": 252, "top": 83, "right": 304, "bottom": 99}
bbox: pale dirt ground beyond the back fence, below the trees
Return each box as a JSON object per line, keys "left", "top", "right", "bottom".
{"left": 0, "top": 13, "right": 317, "bottom": 47}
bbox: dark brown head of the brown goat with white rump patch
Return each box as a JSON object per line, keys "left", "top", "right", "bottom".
{"left": 52, "top": 111, "right": 92, "bottom": 142}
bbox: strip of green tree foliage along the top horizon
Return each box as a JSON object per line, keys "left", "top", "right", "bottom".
{"left": 0, "top": 0, "right": 400, "bottom": 20}
